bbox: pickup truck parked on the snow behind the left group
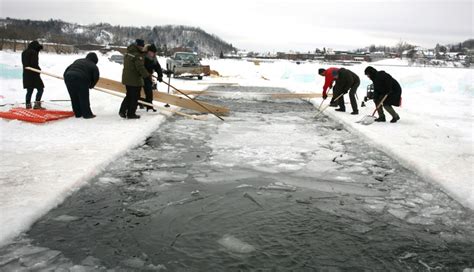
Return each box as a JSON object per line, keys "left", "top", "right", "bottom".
{"left": 166, "top": 52, "right": 211, "bottom": 79}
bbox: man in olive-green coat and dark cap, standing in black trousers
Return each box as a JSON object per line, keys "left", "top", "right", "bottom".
{"left": 119, "top": 39, "right": 151, "bottom": 119}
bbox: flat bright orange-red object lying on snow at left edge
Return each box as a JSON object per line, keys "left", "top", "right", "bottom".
{"left": 0, "top": 108, "right": 74, "bottom": 123}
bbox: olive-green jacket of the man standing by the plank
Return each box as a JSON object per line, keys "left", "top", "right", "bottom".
{"left": 122, "top": 44, "right": 150, "bottom": 87}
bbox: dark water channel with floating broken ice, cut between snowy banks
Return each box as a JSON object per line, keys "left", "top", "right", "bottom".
{"left": 0, "top": 87, "right": 474, "bottom": 271}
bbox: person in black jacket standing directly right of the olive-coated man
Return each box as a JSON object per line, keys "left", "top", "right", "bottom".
{"left": 141, "top": 44, "right": 163, "bottom": 112}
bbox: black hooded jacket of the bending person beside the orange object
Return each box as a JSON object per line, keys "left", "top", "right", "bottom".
{"left": 64, "top": 53, "right": 100, "bottom": 89}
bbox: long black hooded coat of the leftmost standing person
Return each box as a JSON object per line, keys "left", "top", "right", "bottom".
{"left": 21, "top": 41, "right": 44, "bottom": 89}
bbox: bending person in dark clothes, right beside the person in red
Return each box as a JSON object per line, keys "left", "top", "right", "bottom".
{"left": 333, "top": 68, "right": 360, "bottom": 115}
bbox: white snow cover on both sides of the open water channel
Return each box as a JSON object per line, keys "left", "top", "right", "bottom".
{"left": 0, "top": 51, "right": 474, "bottom": 245}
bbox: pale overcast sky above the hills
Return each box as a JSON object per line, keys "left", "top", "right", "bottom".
{"left": 0, "top": 0, "right": 474, "bottom": 52}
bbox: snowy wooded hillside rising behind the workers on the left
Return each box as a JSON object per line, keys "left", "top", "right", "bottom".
{"left": 0, "top": 17, "right": 236, "bottom": 56}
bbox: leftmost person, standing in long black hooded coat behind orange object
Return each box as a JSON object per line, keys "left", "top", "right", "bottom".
{"left": 21, "top": 41, "right": 44, "bottom": 109}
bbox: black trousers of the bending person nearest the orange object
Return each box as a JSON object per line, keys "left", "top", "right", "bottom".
{"left": 64, "top": 73, "right": 93, "bottom": 117}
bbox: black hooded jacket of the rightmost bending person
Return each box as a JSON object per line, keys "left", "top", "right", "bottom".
{"left": 365, "top": 66, "right": 402, "bottom": 106}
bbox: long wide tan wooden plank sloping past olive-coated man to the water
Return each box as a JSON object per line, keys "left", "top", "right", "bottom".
{"left": 96, "top": 77, "right": 229, "bottom": 115}
